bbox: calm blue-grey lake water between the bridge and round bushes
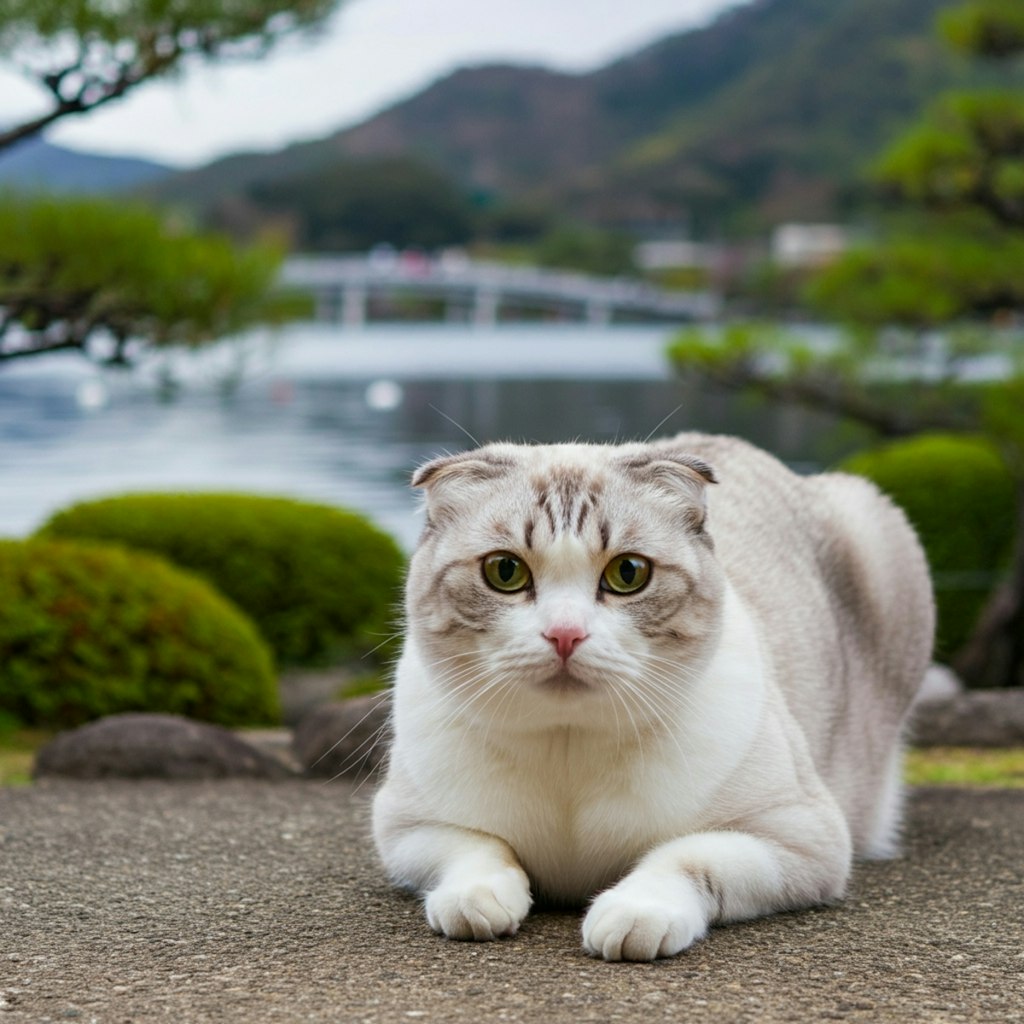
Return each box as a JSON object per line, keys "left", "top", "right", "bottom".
{"left": 0, "top": 325, "right": 860, "bottom": 549}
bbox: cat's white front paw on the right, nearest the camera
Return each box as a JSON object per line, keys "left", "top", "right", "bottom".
{"left": 583, "top": 878, "right": 708, "bottom": 961}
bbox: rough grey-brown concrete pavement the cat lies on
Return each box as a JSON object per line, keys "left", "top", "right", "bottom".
{"left": 0, "top": 781, "right": 1024, "bottom": 1024}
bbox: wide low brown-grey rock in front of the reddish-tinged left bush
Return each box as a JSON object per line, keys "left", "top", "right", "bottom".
{"left": 35, "top": 714, "right": 292, "bottom": 779}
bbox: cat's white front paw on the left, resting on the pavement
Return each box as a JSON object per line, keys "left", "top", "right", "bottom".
{"left": 426, "top": 867, "right": 530, "bottom": 942}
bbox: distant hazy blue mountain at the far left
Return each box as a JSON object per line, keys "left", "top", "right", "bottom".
{"left": 0, "top": 138, "right": 171, "bottom": 194}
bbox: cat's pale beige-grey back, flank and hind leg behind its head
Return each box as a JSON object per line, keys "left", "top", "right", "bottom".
{"left": 668, "top": 434, "right": 935, "bottom": 855}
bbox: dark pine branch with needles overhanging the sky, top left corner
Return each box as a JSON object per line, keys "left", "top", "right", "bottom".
{"left": 0, "top": 0, "right": 339, "bottom": 150}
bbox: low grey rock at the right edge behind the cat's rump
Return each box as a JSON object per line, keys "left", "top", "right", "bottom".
{"left": 910, "top": 689, "right": 1024, "bottom": 746}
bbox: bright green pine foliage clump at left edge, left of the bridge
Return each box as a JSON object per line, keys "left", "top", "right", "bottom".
{"left": 0, "top": 196, "right": 304, "bottom": 361}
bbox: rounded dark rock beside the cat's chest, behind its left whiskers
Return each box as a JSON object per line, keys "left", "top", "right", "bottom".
{"left": 293, "top": 691, "right": 391, "bottom": 778}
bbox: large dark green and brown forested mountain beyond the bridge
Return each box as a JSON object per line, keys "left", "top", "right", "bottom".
{"left": 155, "top": 0, "right": 1007, "bottom": 234}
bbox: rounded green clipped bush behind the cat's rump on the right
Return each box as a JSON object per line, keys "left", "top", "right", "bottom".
{"left": 840, "top": 434, "right": 1014, "bottom": 658}
